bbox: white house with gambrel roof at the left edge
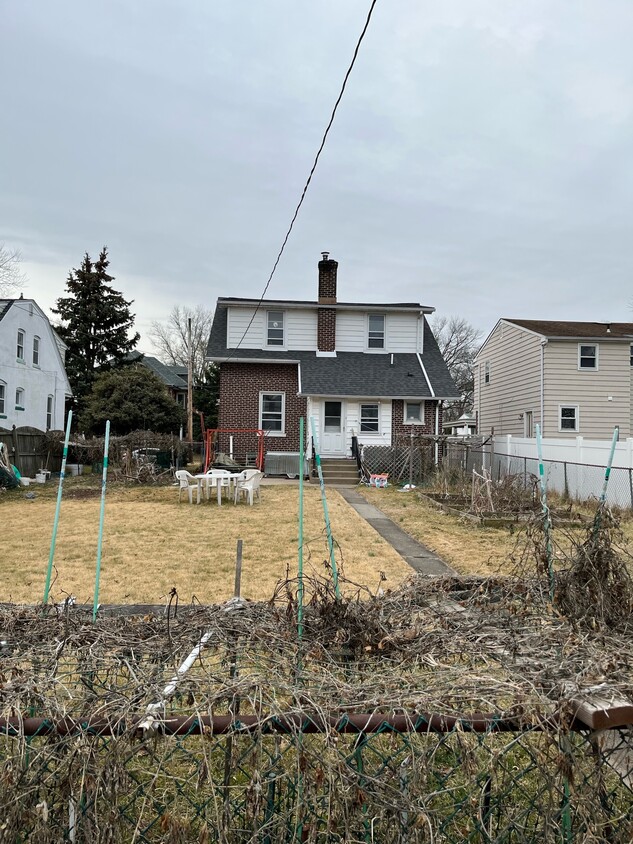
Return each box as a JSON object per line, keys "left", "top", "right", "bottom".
{"left": 0, "top": 299, "right": 71, "bottom": 431}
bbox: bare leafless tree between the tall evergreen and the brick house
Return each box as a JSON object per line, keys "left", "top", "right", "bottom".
{"left": 149, "top": 305, "right": 213, "bottom": 384}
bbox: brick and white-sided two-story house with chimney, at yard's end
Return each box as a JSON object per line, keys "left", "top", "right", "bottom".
{"left": 207, "top": 252, "right": 457, "bottom": 457}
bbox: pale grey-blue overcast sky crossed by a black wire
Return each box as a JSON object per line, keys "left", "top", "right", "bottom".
{"left": 0, "top": 0, "right": 633, "bottom": 352}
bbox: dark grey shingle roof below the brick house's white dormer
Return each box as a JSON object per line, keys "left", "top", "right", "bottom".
{"left": 207, "top": 303, "right": 459, "bottom": 399}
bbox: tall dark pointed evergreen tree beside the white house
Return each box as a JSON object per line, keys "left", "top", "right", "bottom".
{"left": 52, "top": 246, "right": 140, "bottom": 404}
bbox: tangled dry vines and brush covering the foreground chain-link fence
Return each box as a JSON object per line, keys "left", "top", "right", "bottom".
{"left": 0, "top": 520, "right": 633, "bottom": 844}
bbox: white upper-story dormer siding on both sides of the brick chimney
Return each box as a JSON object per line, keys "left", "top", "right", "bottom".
{"left": 227, "top": 304, "right": 424, "bottom": 353}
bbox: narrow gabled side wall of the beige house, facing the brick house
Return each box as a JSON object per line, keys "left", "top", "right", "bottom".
{"left": 474, "top": 320, "right": 542, "bottom": 437}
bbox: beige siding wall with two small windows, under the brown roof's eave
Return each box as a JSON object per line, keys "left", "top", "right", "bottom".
{"left": 540, "top": 340, "right": 631, "bottom": 440}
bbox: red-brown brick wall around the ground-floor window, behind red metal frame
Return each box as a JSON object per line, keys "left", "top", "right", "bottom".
{"left": 218, "top": 363, "right": 307, "bottom": 459}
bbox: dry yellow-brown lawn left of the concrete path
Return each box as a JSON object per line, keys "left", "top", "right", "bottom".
{"left": 0, "top": 478, "right": 411, "bottom": 603}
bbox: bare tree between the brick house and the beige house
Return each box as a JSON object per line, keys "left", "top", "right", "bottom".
{"left": 431, "top": 316, "right": 481, "bottom": 419}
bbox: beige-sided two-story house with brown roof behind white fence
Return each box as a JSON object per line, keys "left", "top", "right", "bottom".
{"left": 474, "top": 319, "right": 633, "bottom": 440}
